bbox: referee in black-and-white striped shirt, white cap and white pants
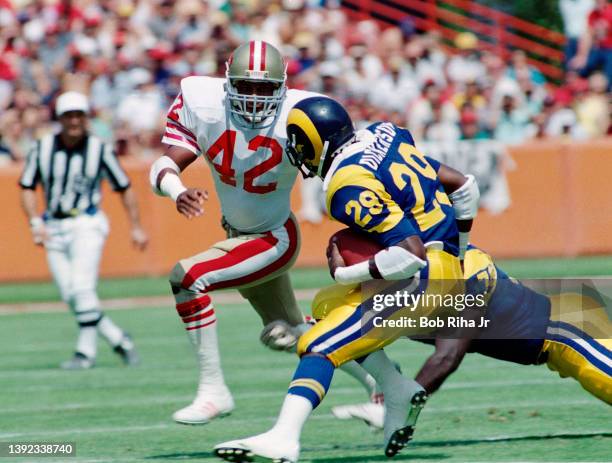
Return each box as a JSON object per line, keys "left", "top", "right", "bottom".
{"left": 19, "top": 92, "right": 148, "bottom": 370}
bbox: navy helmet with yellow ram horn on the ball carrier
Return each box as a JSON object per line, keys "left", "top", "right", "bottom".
{"left": 285, "top": 96, "right": 355, "bottom": 178}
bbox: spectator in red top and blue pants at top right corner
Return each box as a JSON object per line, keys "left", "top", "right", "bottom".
{"left": 570, "top": 0, "right": 612, "bottom": 91}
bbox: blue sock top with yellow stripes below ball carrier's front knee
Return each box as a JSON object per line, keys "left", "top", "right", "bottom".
{"left": 287, "top": 355, "right": 335, "bottom": 409}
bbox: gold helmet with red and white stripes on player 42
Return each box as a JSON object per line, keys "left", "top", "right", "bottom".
{"left": 225, "top": 40, "right": 287, "bottom": 129}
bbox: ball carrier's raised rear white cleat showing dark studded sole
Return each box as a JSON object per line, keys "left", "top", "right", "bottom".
{"left": 384, "top": 389, "right": 427, "bottom": 458}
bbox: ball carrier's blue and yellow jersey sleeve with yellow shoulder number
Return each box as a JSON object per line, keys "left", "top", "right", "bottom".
{"left": 329, "top": 184, "right": 417, "bottom": 247}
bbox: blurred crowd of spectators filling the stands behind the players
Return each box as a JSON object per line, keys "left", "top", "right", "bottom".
{"left": 0, "top": 0, "right": 610, "bottom": 160}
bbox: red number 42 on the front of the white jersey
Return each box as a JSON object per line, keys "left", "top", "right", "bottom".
{"left": 206, "top": 130, "right": 283, "bottom": 194}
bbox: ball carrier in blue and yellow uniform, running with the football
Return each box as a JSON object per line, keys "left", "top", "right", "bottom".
{"left": 215, "top": 97, "right": 479, "bottom": 462}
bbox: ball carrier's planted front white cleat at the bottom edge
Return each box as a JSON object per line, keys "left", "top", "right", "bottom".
{"left": 214, "top": 432, "right": 300, "bottom": 463}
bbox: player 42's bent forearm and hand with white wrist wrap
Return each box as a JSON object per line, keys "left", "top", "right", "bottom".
{"left": 149, "top": 146, "right": 208, "bottom": 219}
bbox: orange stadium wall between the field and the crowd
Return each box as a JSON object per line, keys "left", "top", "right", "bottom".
{"left": 0, "top": 140, "right": 612, "bottom": 281}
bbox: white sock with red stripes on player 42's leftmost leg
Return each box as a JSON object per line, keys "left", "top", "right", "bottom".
{"left": 176, "top": 294, "right": 226, "bottom": 395}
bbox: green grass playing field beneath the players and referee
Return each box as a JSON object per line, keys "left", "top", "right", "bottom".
{"left": 0, "top": 260, "right": 612, "bottom": 463}
